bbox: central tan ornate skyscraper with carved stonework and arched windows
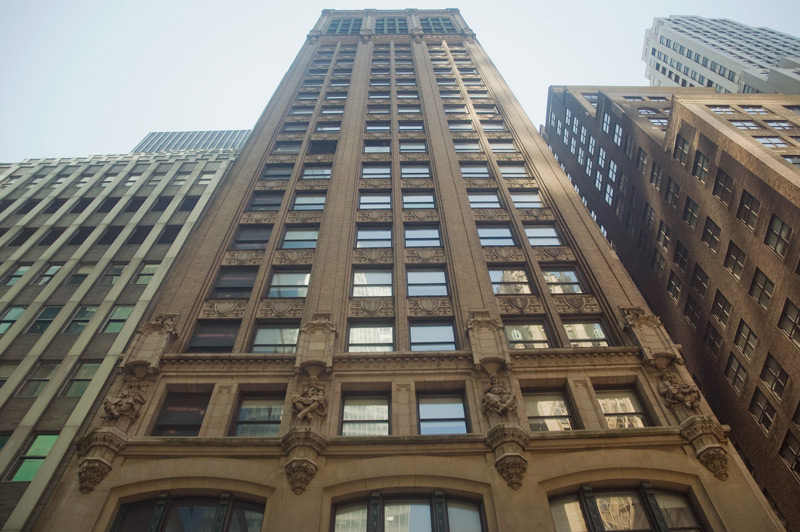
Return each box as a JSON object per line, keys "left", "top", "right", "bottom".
{"left": 15, "top": 10, "right": 780, "bottom": 532}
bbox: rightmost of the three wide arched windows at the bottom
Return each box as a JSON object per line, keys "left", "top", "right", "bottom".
{"left": 550, "top": 487, "right": 703, "bottom": 532}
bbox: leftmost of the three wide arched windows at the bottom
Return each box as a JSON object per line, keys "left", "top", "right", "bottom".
{"left": 111, "top": 493, "right": 264, "bottom": 532}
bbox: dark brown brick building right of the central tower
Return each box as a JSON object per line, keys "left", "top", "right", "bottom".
{"left": 546, "top": 87, "right": 800, "bottom": 530}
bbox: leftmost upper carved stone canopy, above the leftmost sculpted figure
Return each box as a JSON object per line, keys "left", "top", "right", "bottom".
{"left": 122, "top": 314, "right": 178, "bottom": 378}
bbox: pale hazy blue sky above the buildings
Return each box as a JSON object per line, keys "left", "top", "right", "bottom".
{"left": 0, "top": 0, "right": 800, "bottom": 163}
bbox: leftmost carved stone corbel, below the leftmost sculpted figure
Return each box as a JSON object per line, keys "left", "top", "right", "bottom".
{"left": 77, "top": 427, "right": 128, "bottom": 493}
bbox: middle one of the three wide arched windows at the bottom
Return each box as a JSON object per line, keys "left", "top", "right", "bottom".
{"left": 333, "top": 491, "right": 486, "bottom": 532}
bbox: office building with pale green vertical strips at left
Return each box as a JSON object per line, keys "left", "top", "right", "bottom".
{"left": 0, "top": 150, "right": 236, "bottom": 529}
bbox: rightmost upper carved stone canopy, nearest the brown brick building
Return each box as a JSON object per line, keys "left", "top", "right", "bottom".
{"left": 620, "top": 307, "right": 684, "bottom": 371}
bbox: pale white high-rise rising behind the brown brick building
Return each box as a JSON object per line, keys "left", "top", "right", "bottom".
{"left": 642, "top": 16, "right": 800, "bottom": 94}
